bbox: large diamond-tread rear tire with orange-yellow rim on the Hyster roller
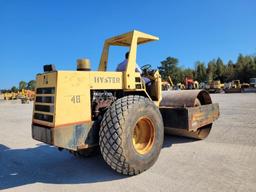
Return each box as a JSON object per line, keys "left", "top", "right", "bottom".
{"left": 99, "top": 95, "right": 164, "bottom": 175}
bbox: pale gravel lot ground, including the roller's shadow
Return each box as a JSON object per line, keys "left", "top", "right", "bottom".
{"left": 0, "top": 93, "right": 256, "bottom": 192}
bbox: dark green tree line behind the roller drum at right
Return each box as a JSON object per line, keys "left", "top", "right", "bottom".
{"left": 158, "top": 54, "right": 256, "bottom": 84}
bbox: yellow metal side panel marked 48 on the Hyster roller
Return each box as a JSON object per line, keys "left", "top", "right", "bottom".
{"left": 55, "top": 71, "right": 91, "bottom": 126}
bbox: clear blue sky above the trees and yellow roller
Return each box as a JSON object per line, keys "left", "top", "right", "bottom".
{"left": 0, "top": 0, "right": 256, "bottom": 89}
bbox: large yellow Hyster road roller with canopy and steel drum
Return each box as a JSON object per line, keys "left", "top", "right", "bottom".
{"left": 32, "top": 31, "right": 219, "bottom": 175}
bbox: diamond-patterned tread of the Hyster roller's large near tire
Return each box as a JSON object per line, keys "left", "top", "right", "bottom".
{"left": 99, "top": 95, "right": 150, "bottom": 175}
